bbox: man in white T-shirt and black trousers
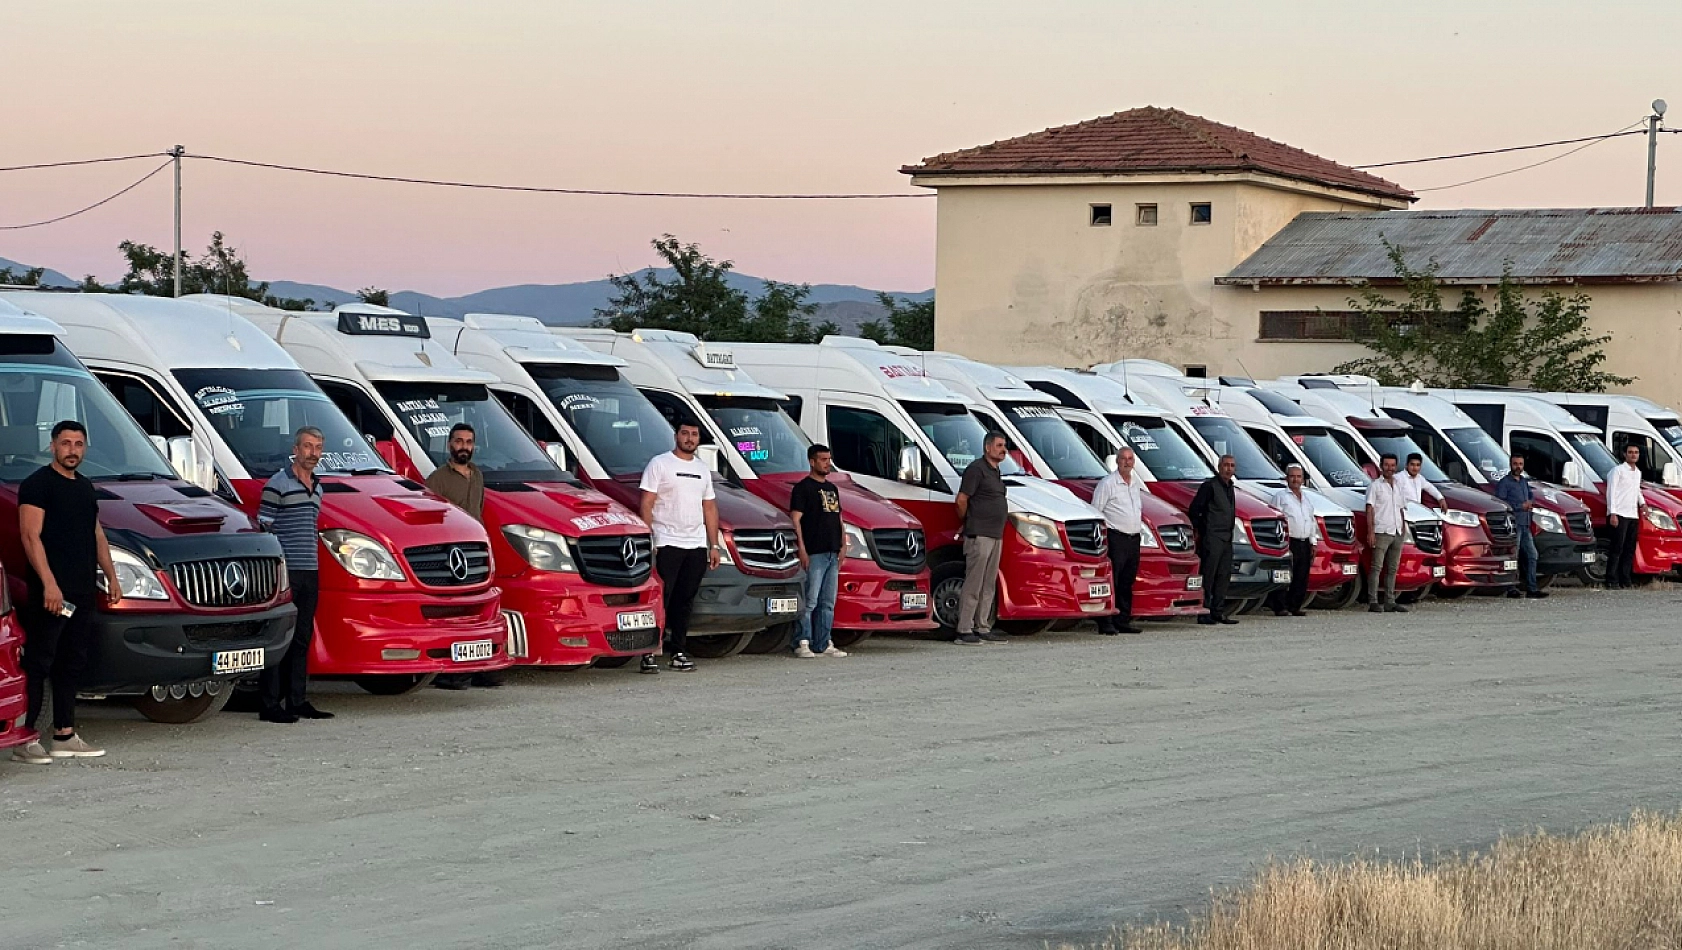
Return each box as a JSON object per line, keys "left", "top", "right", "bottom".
{"left": 643, "top": 422, "right": 718, "bottom": 673}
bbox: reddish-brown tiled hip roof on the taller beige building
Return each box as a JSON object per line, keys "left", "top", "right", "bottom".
{"left": 900, "top": 106, "right": 1413, "bottom": 200}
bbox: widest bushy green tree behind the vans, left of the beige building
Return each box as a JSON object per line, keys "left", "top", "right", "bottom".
{"left": 595, "top": 234, "right": 839, "bottom": 343}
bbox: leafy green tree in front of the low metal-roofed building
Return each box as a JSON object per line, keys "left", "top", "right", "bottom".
{"left": 1334, "top": 242, "right": 1633, "bottom": 392}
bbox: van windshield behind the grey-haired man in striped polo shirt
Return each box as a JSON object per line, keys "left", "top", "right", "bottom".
{"left": 175, "top": 368, "right": 392, "bottom": 479}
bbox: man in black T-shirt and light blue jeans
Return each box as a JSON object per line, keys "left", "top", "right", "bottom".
{"left": 789, "top": 444, "right": 846, "bottom": 657}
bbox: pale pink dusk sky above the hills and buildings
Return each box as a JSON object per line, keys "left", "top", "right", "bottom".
{"left": 0, "top": 0, "right": 1682, "bottom": 294}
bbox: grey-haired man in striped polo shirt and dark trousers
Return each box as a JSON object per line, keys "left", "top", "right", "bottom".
{"left": 257, "top": 425, "right": 333, "bottom": 723}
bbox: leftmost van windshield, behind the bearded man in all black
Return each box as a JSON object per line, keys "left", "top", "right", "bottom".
{"left": 0, "top": 335, "right": 177, "bottom": 481}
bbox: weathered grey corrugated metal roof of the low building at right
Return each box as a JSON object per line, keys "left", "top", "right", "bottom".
{"left": 1216, "top": 208, "right": 1682, "bottom": 284}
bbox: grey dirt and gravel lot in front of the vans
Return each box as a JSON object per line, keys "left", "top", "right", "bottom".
{"left": 0, "top": 587, "right": 1682, "bottom": 950}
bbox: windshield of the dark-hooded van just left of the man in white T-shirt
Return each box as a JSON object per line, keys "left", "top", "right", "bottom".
{"left": 525, "top": 363, "right": 673, "bottom": 476}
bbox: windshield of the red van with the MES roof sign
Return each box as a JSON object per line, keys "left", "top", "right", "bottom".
{"left": 373, "top": 382, "right": 572, "bottom": 483}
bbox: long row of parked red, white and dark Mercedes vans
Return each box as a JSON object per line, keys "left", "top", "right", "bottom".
{"left": 0, "top": 289, "right": 1682, "bottom": 745}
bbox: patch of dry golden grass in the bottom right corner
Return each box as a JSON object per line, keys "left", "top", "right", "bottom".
{"left": 1065, "top": 814, "right": 1682, "bottom": 950}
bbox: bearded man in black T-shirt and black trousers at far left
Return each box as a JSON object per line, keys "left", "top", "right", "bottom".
{"left": 12, "top": 420, "right": 123, "bottom": 765}
